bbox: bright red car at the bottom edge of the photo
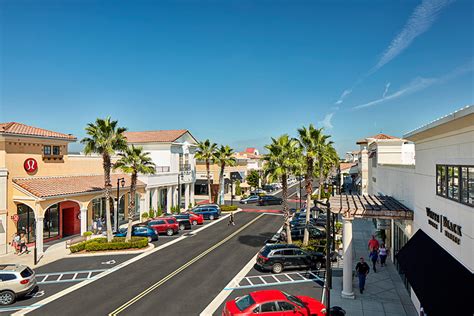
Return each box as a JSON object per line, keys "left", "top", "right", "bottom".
{"left": 222, "top": 290, "right": 326, "bottom": 316}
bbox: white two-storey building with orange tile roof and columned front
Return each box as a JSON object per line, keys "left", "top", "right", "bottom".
{"left": 125, "top": 130, "right": 198, "bottom": 212}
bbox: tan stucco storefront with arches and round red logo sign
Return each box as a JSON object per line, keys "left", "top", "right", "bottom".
{"left": 0, "top": 122, "right": 145, "bottom": 254}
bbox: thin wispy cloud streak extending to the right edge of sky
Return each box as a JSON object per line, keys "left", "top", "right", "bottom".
{"left": 353, "top": 60, "right": 473, "bottom": 110}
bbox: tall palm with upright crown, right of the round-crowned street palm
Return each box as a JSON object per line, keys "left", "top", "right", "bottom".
{"left": 298, "top": 124, "right": 330, "bottom": 246}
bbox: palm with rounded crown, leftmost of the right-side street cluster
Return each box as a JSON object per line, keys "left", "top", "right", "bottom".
{"left": 263, "top": 134, "right": 300, "bottom": 244}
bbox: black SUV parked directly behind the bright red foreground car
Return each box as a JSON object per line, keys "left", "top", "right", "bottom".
{"left": 257, "top": 244, "right": 325, "bottom": 273}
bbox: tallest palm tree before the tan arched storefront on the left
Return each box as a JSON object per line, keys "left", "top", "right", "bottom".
{"left": 81, "top": 117, "right": 127, "bottom": 242}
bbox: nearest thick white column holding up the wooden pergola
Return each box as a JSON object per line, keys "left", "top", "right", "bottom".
{"left": 341, "top": 217, "right": 354, "bottom": 299}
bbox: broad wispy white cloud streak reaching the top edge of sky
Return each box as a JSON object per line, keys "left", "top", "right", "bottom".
{"left": 369, "top": 0, "right": 452, "bottom": 74}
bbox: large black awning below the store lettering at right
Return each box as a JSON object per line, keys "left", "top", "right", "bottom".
{"left": 396, "top": 230, "right": 474, "bottom": 315}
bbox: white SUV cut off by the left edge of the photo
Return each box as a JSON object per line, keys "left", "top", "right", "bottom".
{"left": 0, "top": 264, "right": 38, "bottom": 305}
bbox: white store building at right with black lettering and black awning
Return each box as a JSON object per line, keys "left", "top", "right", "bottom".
{"left": 367, "top": 106, "right": 474, "bottom": 315}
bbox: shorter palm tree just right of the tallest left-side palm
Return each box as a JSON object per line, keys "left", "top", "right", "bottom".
{"left": 114, "top": 145, "right": 155, "bottom": 242}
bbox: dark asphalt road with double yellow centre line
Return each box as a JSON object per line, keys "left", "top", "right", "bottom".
{"left": 31, "top": 212, "right": 282, "bottom": 315}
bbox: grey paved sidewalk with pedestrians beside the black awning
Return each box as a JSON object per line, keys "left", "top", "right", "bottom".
{"left": 331, "top": 220, "right": 418, "bottom": 316}
